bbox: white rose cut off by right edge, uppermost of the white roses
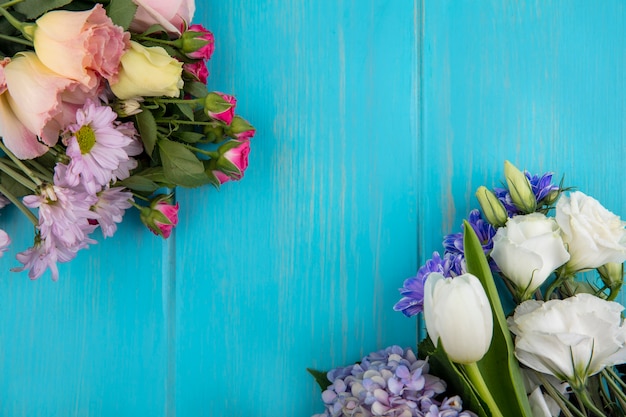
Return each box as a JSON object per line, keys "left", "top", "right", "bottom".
{"left": 556, "top": 191, "right": 626, "bottom": 272}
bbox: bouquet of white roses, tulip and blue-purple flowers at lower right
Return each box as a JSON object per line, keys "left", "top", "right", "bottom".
{"left": 309, "top": 162, "right": 626, "bottom": 417}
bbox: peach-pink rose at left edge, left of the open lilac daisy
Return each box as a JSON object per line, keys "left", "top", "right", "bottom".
{"left": 1, "top": 52, "right": 97, "bottom": 159}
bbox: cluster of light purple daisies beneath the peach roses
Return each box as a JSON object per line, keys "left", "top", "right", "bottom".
{"left": 13, "top": 100, "right": 138, "bottom": 280}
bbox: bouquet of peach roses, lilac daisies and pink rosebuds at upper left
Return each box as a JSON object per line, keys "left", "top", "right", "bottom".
{"left": 0, "top": 0, "right": 255, "bottom": 280}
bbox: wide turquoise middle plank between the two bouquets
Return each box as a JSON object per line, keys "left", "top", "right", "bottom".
{"left": 176, "top": 0, "right": 419, "bottom": 416}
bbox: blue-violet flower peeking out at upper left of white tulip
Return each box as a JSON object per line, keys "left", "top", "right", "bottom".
{"left": 393, "top": 252, "right": 459, "bottom": 317}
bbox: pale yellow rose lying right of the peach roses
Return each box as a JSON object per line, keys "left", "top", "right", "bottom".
{"left": 111, "top": 41, "right": 183, "bottom": 100}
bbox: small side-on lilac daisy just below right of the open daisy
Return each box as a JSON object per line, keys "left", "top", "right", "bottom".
{"left": 91, "top": 187, "right": 133, "bottom": 238}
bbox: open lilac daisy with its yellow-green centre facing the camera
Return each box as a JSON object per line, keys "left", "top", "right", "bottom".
{"left": 66, "top": 100, "right": 132, "bottom": 193}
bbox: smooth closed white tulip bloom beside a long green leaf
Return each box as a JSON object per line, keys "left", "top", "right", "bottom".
{"left": 424, "top": 272, "right": 493, "bottom": 364}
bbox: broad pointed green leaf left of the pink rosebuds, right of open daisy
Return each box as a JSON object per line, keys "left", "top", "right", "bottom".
{"left": 158, "top": 139, "right": 210, "bottom": 187}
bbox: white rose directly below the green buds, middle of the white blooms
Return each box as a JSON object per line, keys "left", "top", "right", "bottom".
{"left": 491, "top": 213, "right": 570, "bottom": 300}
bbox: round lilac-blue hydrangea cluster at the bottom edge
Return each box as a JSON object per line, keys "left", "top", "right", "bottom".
{"left": 314, "top": 346, "right": 476, "bottom": 417}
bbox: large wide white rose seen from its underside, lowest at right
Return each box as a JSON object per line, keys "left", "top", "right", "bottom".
{"left": 508, "top": 294, "right": 626, "bottom": 389}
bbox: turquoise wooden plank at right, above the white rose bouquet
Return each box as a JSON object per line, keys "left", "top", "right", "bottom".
{"left": 420, "top": 0, "right": 626, "bottom": 312}
